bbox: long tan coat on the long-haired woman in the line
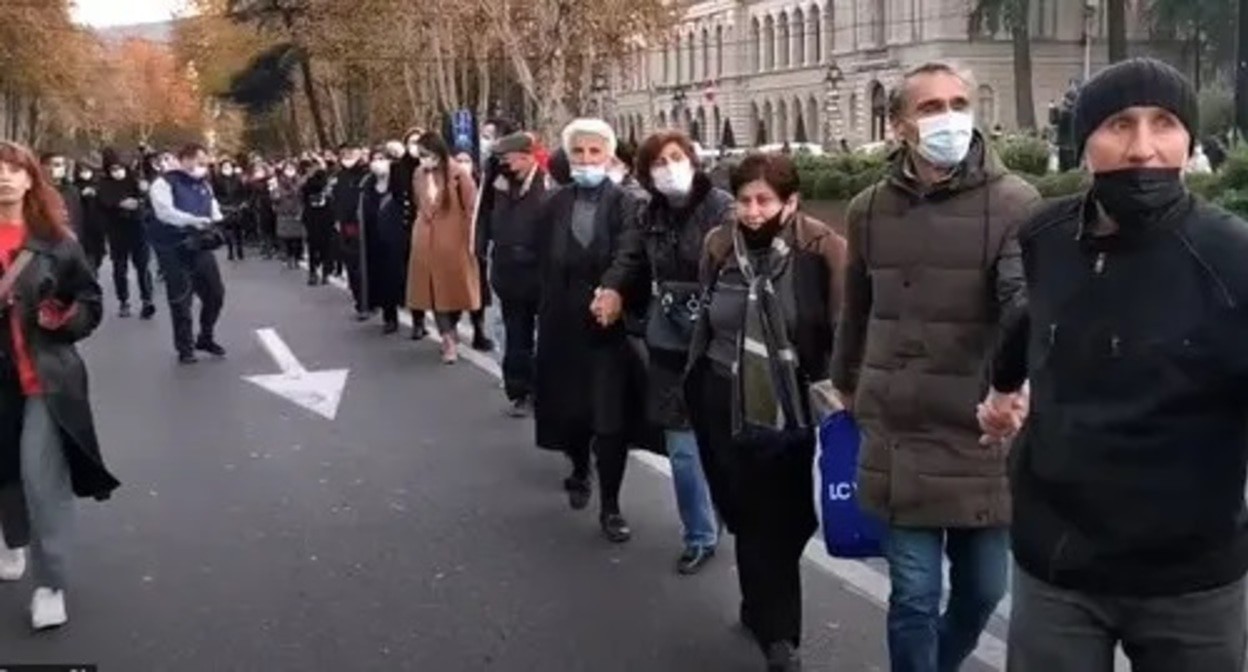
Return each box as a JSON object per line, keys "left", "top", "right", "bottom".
{"left": 407, "top": 165, "right": 480, "bottom": 312}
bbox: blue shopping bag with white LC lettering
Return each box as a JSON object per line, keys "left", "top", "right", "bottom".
{"left": 819, "top": 411, "right": 884, "bottom": 558}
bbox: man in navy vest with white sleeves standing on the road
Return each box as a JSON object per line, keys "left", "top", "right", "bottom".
{"left": 151, "top": 145, "right": 226, "bottom": 365}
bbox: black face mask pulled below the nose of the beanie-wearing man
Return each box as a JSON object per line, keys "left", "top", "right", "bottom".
{"left": 1092, "top": 167, "right": 1187, "bottom": 229}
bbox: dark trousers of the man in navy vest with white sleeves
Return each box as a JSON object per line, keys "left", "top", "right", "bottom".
{"left": 160, "top": 247, "right": 226, "bottom": 353}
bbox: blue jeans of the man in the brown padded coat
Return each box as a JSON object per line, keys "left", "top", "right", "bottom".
{"left": 885, "top": 527, "right": 1010, "bottom": 672}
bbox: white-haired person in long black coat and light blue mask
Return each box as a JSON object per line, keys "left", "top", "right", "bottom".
{"left": 533, "top": 119, "right": 643, "bottom": 543}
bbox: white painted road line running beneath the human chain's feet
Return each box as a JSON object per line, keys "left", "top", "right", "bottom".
{"left": 316, "top": 266, "right": 1028, "bottom": 671}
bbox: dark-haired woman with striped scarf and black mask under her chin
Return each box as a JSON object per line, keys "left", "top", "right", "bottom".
{"left": 683, "top": 154, "right": 845, "bottom": 672}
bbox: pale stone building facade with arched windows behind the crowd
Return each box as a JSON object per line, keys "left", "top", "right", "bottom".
{"left": 607, "top": 0, "right": 1177, "bottom": 147}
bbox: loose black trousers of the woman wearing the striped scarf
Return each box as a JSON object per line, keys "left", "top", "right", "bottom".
{"left": 690, "top": 363, "right": 817, "bottom": 650}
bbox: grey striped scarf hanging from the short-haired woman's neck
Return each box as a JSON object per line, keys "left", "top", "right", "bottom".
{"left": 733, "top": 222, "right": 811, "bottom": 435}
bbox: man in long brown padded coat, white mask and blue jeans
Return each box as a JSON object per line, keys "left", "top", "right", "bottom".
{"left": 832, "top": 62, "right": 1040, "bottom": 672}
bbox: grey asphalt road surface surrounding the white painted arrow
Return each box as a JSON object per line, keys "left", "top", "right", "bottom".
{"left": 0, "top": 253, "right": 1003, "bottom": 672}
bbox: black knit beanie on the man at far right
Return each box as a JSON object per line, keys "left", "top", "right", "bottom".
{"left": 1075, "top": 59, "right": 1201, "bottom": 156}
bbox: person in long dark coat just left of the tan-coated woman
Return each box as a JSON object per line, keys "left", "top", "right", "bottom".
{"left": 359, "top": 150, "right": 412, "bottom": 335}
